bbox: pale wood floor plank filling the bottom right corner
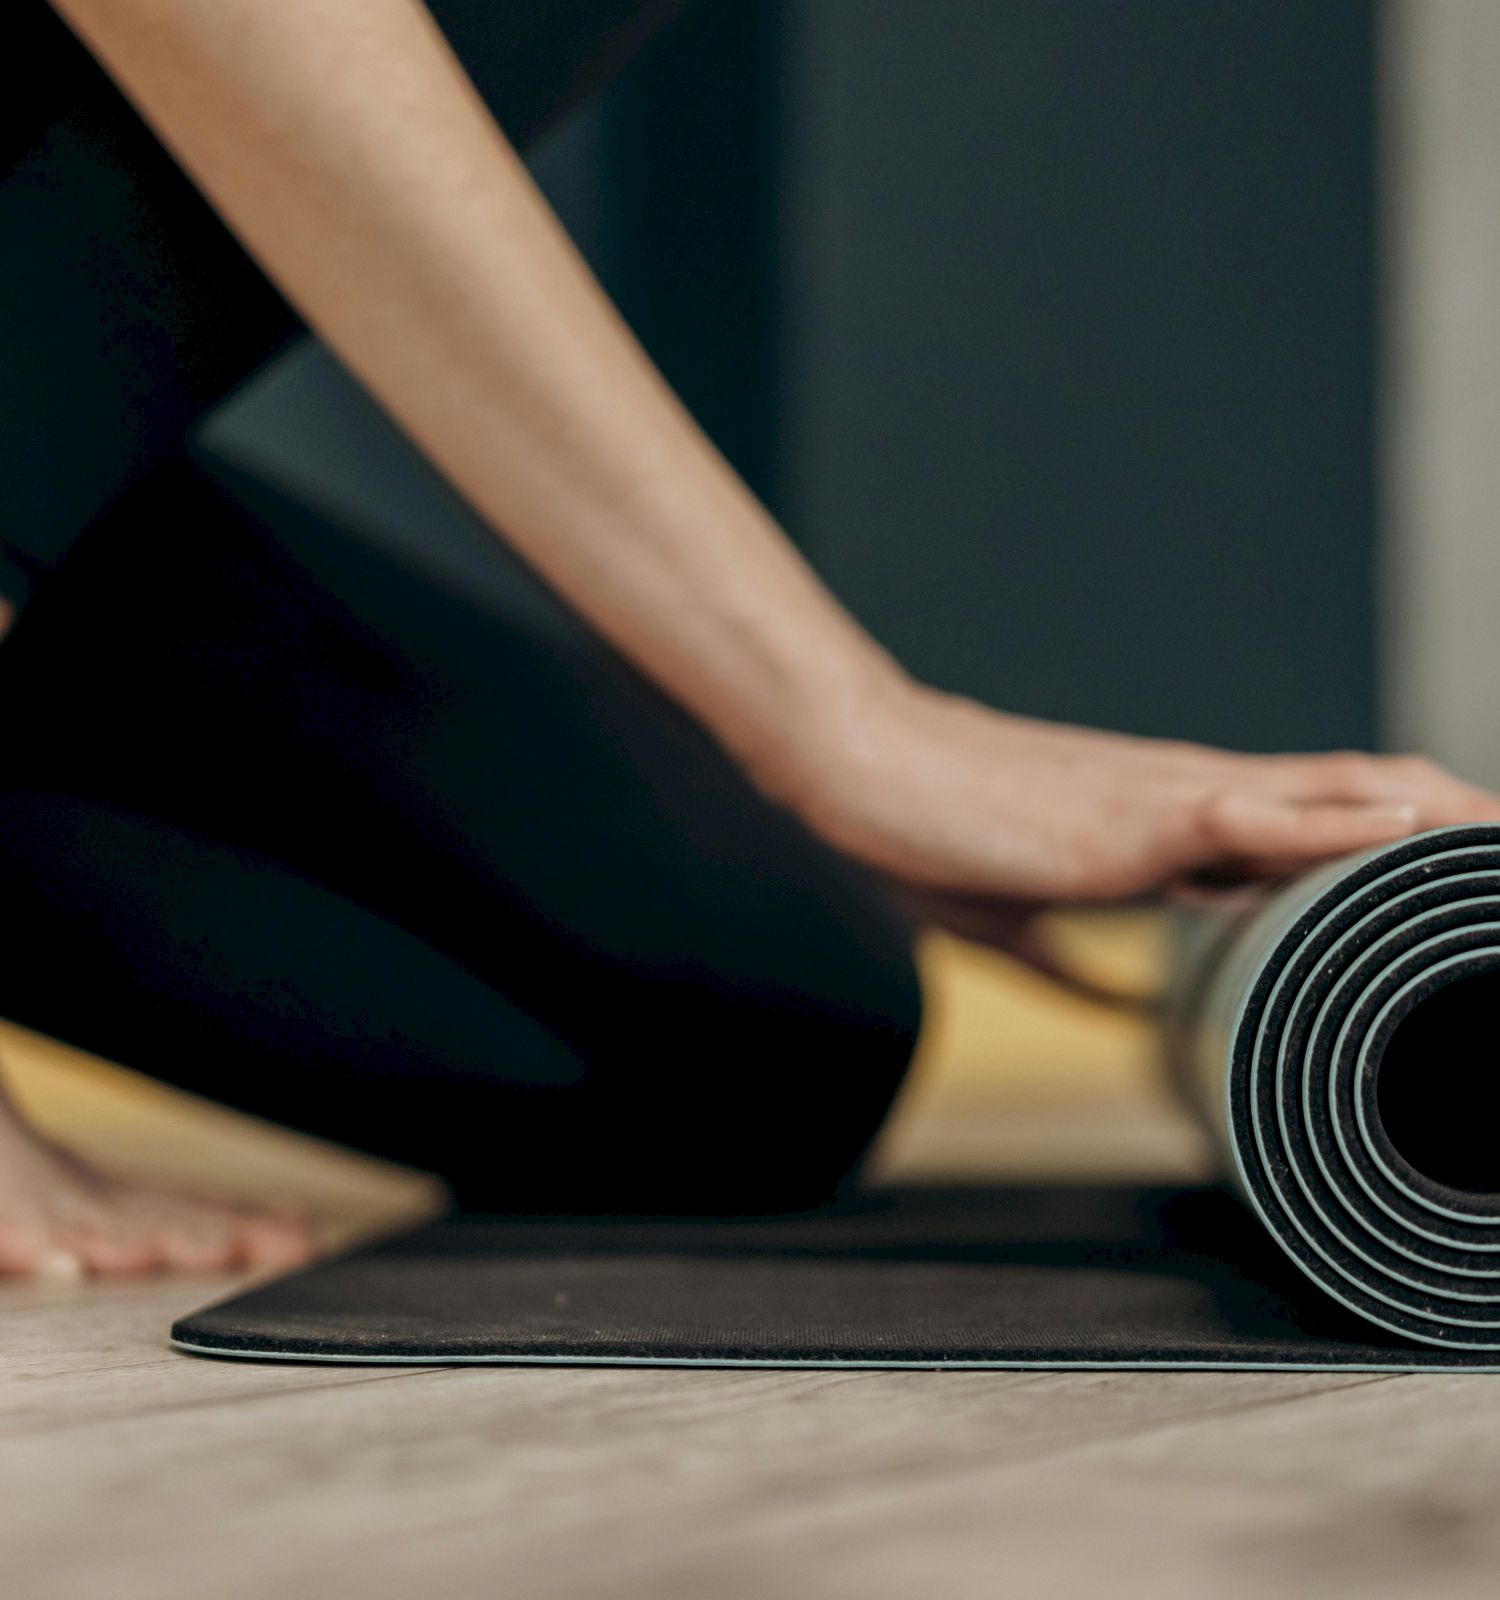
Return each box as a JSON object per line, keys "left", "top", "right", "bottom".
{"left": 530, "top": 1374, "right": 1500, "bottom": 1600}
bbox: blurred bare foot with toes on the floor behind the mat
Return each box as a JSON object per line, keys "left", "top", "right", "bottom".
{"left": 0, "top": 1090, "right": 312, "bottom": 1277}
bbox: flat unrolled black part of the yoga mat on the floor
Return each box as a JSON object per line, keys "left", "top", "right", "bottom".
{"left": 173, "top": 1186, "right": 1500, "bottom": 1371}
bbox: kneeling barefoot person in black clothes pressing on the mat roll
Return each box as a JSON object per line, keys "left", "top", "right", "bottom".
{"left": 0, "top": 0, "right": 1500, "bottom": 1272}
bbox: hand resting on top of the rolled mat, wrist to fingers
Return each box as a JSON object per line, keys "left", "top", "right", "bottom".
{"left": 782, "top": 680, "right": 1500, "bottom": 915}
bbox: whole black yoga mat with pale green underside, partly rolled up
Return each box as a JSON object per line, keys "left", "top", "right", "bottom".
{"left": 173, "top": 827, "right": 1500, "bottom": 1371}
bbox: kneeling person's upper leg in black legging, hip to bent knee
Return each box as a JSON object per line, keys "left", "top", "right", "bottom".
{"left": 0, "top": 469, "right": 918, "bottom": 1197}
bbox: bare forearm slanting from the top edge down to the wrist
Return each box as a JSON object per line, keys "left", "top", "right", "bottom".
{"left": 49, "top": 0, "right": 897, "bottom": 787}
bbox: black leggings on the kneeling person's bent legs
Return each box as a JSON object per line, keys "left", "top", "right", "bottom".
{"left": 0, "top": 0, "right": 920, "bottom": 1211}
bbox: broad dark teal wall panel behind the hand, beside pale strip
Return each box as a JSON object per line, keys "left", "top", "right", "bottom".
{"left": 784, "top": 0, "right": 1374, "bottom": 747}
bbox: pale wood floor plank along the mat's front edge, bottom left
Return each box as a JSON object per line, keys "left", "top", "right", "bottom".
{"left": 0, "top": 1368, "right": 1369, "bottom": 1600}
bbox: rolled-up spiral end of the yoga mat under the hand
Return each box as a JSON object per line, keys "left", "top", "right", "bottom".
{"left": 1167, "top": 826, "right": 1500, "bottom": 1350}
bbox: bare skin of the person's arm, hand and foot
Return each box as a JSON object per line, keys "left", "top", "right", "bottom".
{"left": 0, "top": 0, "right": 1500, "bottom": 1272}
